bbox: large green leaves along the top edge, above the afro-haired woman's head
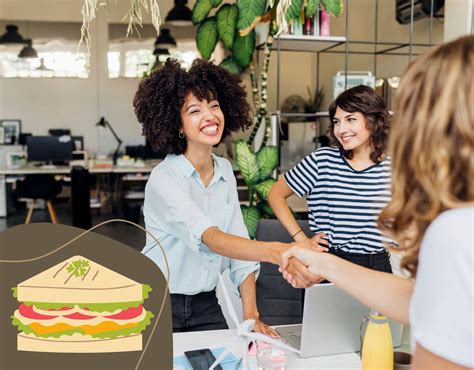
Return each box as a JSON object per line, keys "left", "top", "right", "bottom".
{"left": 192, "top": 0, "right": 342, "bottom": 73}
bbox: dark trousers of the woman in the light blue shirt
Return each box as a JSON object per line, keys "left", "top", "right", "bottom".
{"left": 171, "top": 289, "right": 229, "bottom": 333}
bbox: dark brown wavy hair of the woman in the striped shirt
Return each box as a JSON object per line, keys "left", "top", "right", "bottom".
{"left": 329, "top": 85, "right": 390, "bottom": 163}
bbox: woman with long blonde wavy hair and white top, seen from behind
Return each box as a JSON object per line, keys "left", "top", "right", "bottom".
{"left": 282, "top": 36, "right": 474, "bottom": 370}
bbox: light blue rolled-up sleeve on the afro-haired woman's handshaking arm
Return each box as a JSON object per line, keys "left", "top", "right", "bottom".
{"left": 146, "top": 172, "right": 217, "bottom": 252}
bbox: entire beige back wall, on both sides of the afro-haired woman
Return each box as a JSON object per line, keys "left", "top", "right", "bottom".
{"left": 0, "top": 0, "right": 443, "bottom": 153}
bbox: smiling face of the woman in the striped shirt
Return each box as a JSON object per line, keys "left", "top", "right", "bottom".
{"left": 333, "top": 107, "right": 370, "bottom": 153}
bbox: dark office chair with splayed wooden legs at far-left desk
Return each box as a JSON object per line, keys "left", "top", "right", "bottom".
{"left": 18, "top": 175, "right": 62, "bottom": 224}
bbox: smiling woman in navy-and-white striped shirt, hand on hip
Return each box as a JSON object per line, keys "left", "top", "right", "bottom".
{"left": 268, "top": 86, "right": 392, "bottom": 280}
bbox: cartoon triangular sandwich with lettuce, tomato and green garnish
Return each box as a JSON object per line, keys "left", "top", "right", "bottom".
{"left": 12, "top": 256, "right": 154, "bottom": 353}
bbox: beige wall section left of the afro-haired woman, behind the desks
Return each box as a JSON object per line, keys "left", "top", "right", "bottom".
{"left": 0, "top": 0, "right": 172, "bottom": 153}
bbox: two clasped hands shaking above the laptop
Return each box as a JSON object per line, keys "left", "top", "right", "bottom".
{"left": 278, "top": 233, "right": 329, "bottom": 288}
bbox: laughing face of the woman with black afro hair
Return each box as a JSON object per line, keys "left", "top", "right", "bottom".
{"left": 181, "top": 93, "right": 224, "bottom": 149}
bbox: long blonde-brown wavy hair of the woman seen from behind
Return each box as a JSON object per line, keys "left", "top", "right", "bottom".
{"left": 378, "top": 36, "right": 474, "bottom": 277}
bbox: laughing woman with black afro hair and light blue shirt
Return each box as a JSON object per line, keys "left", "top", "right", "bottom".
{"left": 133, "top": 59, "right": 318, "bottom": 335}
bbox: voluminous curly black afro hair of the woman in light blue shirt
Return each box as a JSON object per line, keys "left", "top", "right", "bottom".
{"left": 133, "top": 58, "right": 252, "bottom": 154}
